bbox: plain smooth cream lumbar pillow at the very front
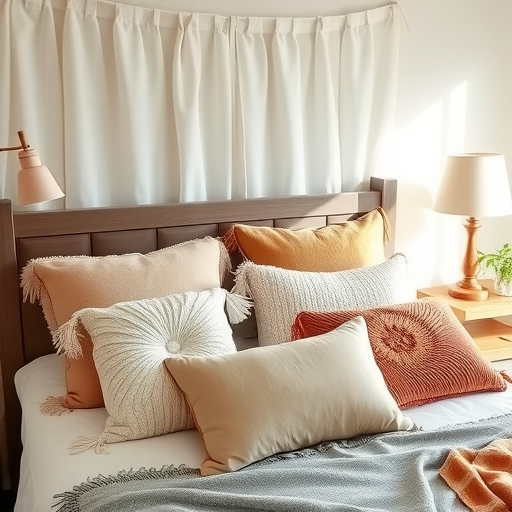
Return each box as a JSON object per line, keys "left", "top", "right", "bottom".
{"left": 165, "top": 317, "right": 416, "bottom": 475}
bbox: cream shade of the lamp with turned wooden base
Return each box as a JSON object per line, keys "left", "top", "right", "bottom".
{"left": 434, "top": 153, "right": 512, "bottom": 217}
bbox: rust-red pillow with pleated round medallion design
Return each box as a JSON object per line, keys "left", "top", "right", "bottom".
{"left": 293, "top": 299, "right": 507, "bottom": 409}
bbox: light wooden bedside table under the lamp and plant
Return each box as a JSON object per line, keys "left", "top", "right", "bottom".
{"left": 416, "top": 279, "right": 512, "bottom": 361}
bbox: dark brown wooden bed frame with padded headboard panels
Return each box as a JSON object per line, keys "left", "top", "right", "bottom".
{"left": 0, "top": 178, "right": 397, "bottom": 490}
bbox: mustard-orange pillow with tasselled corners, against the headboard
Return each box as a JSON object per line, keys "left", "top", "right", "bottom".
{"left": 224, "top": 208, "right": 389, "bottom": 272}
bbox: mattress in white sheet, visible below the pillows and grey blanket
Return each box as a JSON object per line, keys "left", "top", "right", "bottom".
{"left": 15, "top": 352, "right": 512, "bottom": 512}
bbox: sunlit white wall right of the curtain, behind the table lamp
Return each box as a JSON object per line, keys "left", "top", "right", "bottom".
{"left": 388, "top": 0, "right": 512, "bottom": 286}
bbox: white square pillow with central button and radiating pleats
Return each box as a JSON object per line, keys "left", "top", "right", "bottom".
{"left": 57, "top": 288, "right": 244, "bottom": 453}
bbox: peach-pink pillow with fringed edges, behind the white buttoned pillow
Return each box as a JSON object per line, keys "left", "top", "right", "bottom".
{"left": 21, "top": 237, "right": 229, "bottom": 414}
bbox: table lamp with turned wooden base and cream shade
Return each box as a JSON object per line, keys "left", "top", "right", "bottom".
{"left": 434, "top": 153, "right": 512, "bottom": 301}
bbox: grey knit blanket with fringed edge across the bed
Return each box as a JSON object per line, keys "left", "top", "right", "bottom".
{"left": 53, "top": 414, "right": 512, "bottom": 512}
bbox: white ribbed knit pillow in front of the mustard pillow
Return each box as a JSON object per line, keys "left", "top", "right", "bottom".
{"left": 233, "top": 253, "right": 414, "bottom": 345}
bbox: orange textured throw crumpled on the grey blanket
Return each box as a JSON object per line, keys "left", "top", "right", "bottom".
{"left": 439, "top": 439, "right": 512, "bottom": 512}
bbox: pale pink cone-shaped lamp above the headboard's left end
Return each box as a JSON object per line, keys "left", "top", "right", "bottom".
{"left": 0, "top": 131, "right": 64, "bottom": 206}
